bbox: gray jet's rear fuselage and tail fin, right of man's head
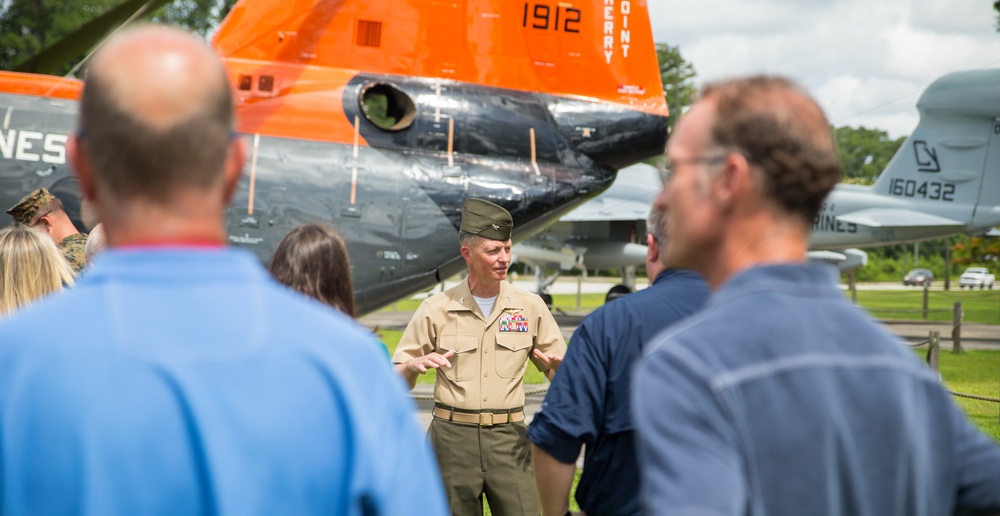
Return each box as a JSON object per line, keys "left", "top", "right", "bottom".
{"left": 809, "top": 70, "right": 1000, "bottom": 266}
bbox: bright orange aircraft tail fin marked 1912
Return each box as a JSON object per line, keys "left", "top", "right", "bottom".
{"left": 213, "top": 0, "right": 667, "bottom": 116}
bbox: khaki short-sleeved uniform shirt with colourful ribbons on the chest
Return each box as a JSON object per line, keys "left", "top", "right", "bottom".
{"left": 392, "top": 280, "right": 566, "bottom": 410}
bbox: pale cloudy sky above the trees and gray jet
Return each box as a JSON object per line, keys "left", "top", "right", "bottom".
{"left": 647, "top": 0, "right": 1000, "bottom": 138}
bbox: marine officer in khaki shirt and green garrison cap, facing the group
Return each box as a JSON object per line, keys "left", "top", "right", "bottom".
{"left": 392, "top": 199, "right": 566, "bottom": 516}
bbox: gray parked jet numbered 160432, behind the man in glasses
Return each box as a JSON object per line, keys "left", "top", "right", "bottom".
{"left": 514, "top": 70, "right": 1000, "bottom": 295}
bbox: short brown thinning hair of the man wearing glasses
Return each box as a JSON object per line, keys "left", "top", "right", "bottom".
{"left": 702, "top": 76, "right": 842, "bottom": 225}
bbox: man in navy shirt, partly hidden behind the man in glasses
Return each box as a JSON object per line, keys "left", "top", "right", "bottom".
{"left": 528, "top": 211, "right": 708, "bottom": 516}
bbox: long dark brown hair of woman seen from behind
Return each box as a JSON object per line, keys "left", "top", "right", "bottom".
{"left": 270, "top": 224, "right": 354, "bottom": 317}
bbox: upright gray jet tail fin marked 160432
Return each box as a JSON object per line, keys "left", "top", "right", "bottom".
{"left": 873, "top": 70, "right": 1000, "bottom": 230}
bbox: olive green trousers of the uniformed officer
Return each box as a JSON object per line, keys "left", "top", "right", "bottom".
{"left": 428, "top": 418, "right": 541, "bottom": 516}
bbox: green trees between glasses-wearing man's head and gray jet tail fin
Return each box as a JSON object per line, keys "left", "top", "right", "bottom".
{"left": 833, "top": 126, "right": 906, "bottom": 184}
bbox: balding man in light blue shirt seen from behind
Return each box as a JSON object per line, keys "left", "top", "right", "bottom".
{"left": 0, "top": 27, "right": 447, "bottom": 515}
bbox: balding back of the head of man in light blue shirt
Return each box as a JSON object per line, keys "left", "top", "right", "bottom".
{"left": 80, "top": 25, "right": 233, "bottom": 204}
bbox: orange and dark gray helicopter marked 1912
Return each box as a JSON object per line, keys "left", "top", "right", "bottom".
{"left": 0, "top": 0, "right": 667, "bottom": 312}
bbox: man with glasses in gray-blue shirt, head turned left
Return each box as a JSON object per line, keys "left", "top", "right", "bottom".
{"left": 632, "top": 77, "right": 1000, "bottom": 516}
